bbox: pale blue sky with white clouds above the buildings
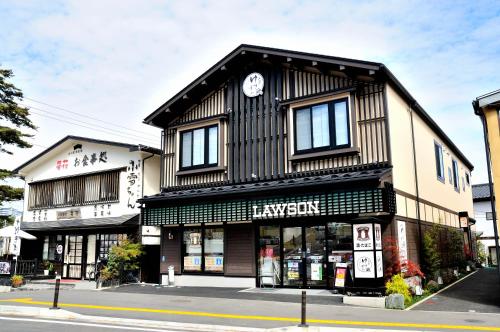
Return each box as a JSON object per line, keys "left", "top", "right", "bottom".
{"left": 0, "top": 0, "right": 500, "bottom": 189}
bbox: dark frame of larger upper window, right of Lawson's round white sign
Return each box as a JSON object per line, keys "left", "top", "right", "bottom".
{"left": 292, "top": 97, "right": 352, "bottom": 155}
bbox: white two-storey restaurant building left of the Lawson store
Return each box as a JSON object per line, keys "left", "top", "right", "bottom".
{"left": 14, "top": 136, "right": 161, "bottom": 281}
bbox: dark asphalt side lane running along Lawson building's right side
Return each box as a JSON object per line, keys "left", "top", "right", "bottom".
{"left": 412, "top": 268, "right": 500, "bottom": 314}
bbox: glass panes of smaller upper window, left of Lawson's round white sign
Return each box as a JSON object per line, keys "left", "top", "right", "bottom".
{"left": 180, "top": 125, "right": 219, "bottom": 169}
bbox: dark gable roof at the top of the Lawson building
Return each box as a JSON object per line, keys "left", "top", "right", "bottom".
{"left": 143, "top": 44, "right": 474, "bottom": 170}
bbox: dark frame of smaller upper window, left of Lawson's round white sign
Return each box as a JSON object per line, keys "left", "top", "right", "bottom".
{"left": 179, "top": 123, "right": 220, "bottom": 171}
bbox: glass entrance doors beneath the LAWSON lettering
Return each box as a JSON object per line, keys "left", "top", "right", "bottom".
{"left": 283, "top": 225, "right": 327, "bottom": 288}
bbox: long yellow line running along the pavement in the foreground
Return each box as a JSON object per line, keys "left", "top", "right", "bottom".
{"left": 0, "top": 298, "right": 500, "bottom": 331}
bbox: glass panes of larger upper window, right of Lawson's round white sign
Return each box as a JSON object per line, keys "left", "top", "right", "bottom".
{"left": 294, "top": 98, "right": 350, "bottom": 153}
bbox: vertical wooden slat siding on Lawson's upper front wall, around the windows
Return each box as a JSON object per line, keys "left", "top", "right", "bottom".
{"left": 161, "top": 64, "right": 390, "bottom": 189}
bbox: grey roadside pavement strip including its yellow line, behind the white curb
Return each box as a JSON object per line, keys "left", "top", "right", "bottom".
{"left": 0, "top": 290, "right": 500, "bottom": 331}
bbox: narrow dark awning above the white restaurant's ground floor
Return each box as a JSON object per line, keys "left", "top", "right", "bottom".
{"left": 21, "top": 214, "right": 139, "bottom": 231}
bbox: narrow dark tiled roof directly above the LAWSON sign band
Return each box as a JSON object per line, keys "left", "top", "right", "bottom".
{"left": 139, "top": 167, "right": 391, "bottom": 203}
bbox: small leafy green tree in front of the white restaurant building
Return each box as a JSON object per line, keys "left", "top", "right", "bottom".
{"left": 101, "top": 240, "right": 144, "bottom": 280}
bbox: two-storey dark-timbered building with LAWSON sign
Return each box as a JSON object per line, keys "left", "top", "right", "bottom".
{"left": 140, "top": 45, "right": 473, "bottom": 288}
